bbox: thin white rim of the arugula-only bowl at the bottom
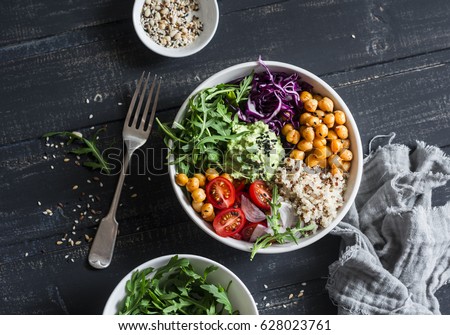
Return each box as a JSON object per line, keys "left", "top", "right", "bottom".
{"left": 103, "top": 254, "right": 259, "bottom": 315}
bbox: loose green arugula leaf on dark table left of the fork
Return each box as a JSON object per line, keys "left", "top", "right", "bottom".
{"left": 42, "top": 128, "right": 111, "bottom": 174}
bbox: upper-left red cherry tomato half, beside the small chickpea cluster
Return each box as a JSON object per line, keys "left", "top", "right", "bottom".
{"left": 206, "top": 177, "right": 236, "bottom": 209}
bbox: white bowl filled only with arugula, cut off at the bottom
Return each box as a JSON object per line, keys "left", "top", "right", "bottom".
{"left": 103, "top": 254, "right": 258, "bottom": 315}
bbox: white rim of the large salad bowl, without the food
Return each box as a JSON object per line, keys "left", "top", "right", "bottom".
{"left": 169, "top": 61, "right": 363, "bottom": 254}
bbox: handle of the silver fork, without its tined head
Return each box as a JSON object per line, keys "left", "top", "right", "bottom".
{"left": 88, "top": 148, "right": 135, "bottom": 269}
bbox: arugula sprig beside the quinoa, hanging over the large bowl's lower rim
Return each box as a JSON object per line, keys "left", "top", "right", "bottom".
{"left": 250, "top": 185, "right": 317, "bottom": 260}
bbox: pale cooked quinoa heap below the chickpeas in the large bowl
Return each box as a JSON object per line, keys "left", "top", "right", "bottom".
{"left": 275, "top": 158, "right": 347, "bottom": 227}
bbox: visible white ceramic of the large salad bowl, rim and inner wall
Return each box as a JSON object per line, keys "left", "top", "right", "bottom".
{"left": 169, "top": 61, "right": 363, "bottom": 254}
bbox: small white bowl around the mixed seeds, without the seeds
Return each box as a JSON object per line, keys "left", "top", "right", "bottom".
{"left": 133, "top": 0, "right": 219, "bottom": 58}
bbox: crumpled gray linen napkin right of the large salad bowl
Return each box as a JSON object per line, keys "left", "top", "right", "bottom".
{"left": 327, "top": 134, "right": 450, "bottom": 314}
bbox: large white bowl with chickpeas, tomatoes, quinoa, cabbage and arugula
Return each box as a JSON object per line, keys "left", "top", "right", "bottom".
{"left": 157, "top": 59, "right": 363, "bottom": 258}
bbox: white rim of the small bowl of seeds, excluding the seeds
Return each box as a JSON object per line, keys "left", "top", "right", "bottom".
{"left": 132, "top": 0, "right": 219, "bottom": 58}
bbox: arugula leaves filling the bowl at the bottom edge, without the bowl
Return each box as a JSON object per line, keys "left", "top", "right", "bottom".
{"left": 119, "top": 255, "right": 239, "bottom": 315}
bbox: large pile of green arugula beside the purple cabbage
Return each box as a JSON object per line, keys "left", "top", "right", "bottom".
{"left": 156, "top": 73, "right": 253, "bottom": 175}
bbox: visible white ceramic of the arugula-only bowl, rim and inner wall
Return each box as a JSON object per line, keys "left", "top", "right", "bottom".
{"left": 103, "top": 254, "right": 258, "bottom": 315}
